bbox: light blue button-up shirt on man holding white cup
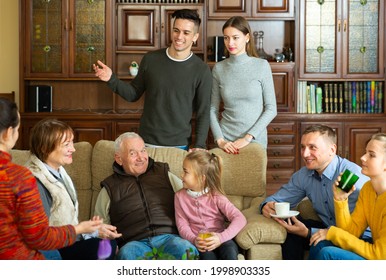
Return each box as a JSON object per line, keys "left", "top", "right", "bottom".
{"left": 260, "top": 155, "right": 370, "bottom": 236}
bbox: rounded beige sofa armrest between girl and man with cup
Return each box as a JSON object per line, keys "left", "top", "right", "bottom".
{"left": 236, "top": 205, "right": 287, "bottom": 250}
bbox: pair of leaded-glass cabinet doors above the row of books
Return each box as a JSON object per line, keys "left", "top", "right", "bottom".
{"left": 298, "top": 0, "right": 385, "bottom": 79}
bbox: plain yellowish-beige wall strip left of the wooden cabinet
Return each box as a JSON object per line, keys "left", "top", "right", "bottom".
{"left": 0, "top": 0, "right": 19, "bottom": 103}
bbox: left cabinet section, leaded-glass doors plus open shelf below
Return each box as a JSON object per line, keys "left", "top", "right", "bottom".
{"left": 19, "top": 0, "right": 113, "bottom": 113}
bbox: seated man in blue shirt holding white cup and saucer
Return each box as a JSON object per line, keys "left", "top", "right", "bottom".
{"left": 260, "top": 125, "right": 370, "bottom": 260}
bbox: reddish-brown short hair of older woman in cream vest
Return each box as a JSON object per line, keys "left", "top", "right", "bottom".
{"left": 30, "top": 119, "right": 74, "bottom": 162}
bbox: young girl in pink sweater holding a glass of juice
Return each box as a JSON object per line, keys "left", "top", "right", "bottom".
{"left": 174, "top": 151, "right": 247, "bottom": 260}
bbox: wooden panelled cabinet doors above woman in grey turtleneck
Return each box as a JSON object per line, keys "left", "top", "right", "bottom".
{"left": 207, "top": 0, "right": 294, "bottom": 19}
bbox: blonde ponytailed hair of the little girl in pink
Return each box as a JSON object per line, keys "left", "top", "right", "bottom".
{"left": 185, "top": 151, "right": 225, "bottom": 195}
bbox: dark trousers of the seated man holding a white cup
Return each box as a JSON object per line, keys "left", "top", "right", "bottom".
{"left": 281, "top": 216, "right": 326, "bottom": 260}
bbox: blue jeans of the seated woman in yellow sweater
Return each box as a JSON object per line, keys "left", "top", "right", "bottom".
{"left": 308, "top": 240, "right": 365, "bottom": 260}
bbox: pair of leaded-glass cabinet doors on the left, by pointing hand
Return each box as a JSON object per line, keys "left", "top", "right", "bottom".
{"left": 21, "top": 0, "right": 112, "bottom": 78}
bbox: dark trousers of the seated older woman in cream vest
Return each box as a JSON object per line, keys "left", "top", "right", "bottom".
{"left": 59, "top": 238, "right": 117, "bottom": 260}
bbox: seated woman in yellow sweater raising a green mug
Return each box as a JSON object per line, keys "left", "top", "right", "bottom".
{"left": 310, "top": 133, "right": 386, "bottom": 260}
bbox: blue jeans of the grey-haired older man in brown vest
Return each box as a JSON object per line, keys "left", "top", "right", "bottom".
{"left": 116, "top": 234, "right": 198, "bottom": 260}
